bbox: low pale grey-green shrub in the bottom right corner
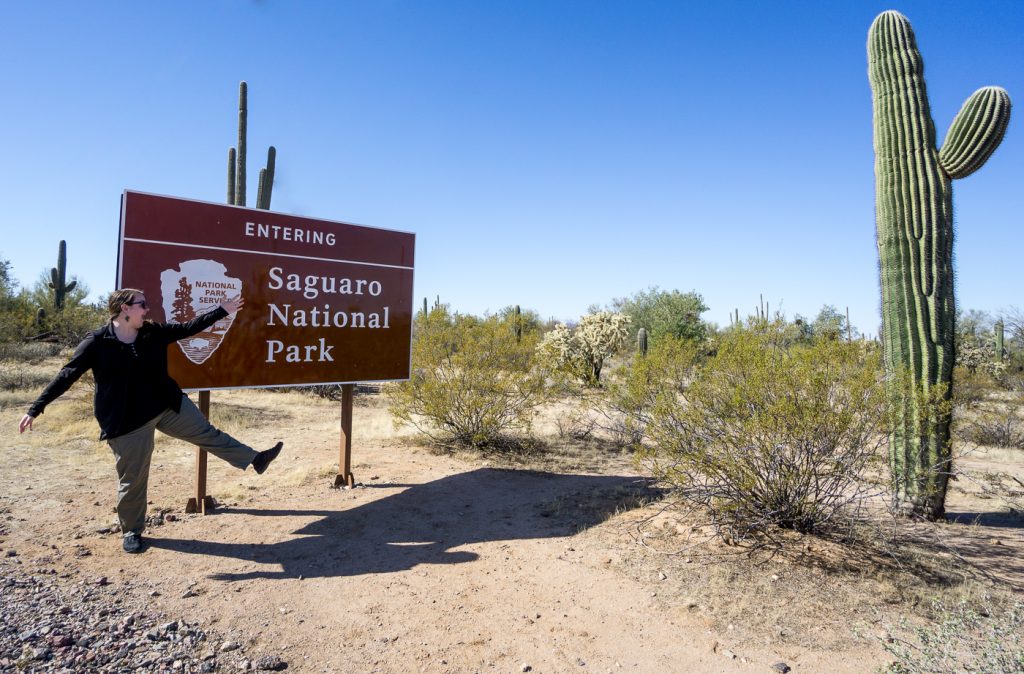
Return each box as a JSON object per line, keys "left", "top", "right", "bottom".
{"left": 883, "top": 601, "right": 1024, "bottom": 674}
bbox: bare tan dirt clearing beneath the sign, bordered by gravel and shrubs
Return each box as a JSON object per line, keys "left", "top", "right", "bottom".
{"left": 0, "top": 393, "right": 913, "bottom": 673}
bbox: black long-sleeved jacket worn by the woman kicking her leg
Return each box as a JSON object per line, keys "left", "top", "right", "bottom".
{"left": 29, "top": 306, "right": 227, "bottom": 439}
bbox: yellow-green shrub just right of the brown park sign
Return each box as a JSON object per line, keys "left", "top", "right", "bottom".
{"left": 387, "top": 306, "right": 547, "bottom": 447}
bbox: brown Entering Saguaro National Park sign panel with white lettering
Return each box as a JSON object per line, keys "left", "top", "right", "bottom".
{"left": 118, "top": 191, "right": 416, "bottom": 389}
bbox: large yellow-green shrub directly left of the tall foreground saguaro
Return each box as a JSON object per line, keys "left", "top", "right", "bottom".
{"left": 641, "top": 324, "right": 886, "bottom": 545}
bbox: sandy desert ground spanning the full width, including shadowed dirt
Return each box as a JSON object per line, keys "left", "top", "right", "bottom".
{"left": 0, "top": 376, "right": 1024, "bottom": 673}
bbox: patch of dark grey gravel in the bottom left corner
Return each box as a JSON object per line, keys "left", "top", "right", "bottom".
{"left": 0, "top": 555, "right": 288, "bottom": 674}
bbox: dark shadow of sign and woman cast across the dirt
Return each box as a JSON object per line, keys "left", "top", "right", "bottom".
{"left": 150, "top": 468, "right": 660, "bottom": 581}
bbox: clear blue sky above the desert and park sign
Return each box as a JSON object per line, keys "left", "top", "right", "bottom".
{"left": 0, "top": 0, "right": 1024, "bottom": 334}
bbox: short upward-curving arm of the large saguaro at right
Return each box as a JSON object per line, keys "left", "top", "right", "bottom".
{"left": 939, "top": 87, "right": 1011, "bottom": 179}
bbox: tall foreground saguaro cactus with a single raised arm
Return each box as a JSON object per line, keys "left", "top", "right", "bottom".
{"left": 867, "top": 11, "right": 1010, "bottom": 518}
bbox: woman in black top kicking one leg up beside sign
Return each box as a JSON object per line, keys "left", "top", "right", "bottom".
{"left": 18, "top": 288, "right": 283, "bottom": 552}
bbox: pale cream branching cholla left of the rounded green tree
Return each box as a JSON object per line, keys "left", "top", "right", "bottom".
{"left": 537, "top": 311, "right": 630, "bottom": 386}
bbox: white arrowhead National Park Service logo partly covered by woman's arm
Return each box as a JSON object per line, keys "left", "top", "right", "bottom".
{"left": 160, "top": 260, "right": 242, "bottom": 365}
